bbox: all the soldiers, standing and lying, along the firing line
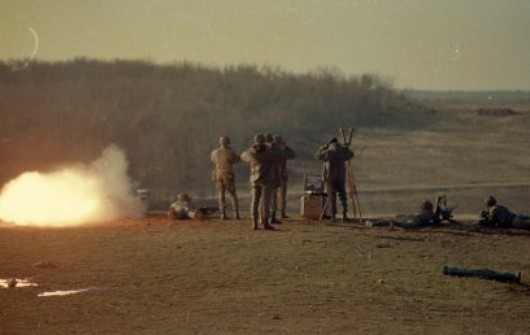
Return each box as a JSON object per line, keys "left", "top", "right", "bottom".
{"left": 169, "top": 134, "right": 530, "bottom": 230}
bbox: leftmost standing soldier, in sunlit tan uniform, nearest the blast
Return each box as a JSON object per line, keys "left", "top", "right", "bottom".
{"left": 210, "top": 136, "right": 241, "bottom": 220}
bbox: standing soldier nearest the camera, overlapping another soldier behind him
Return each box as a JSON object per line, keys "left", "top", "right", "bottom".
{"left": 241, "top": 135, "right": 276, "bottom": 230}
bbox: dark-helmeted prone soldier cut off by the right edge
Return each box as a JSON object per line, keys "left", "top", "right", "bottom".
{"left": 478, "top": 196, "right": 530, "bottom": 229}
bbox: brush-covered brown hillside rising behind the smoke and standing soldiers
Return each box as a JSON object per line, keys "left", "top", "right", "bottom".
{"left": 0, "top": 59, "right": 436, "bottom": 203}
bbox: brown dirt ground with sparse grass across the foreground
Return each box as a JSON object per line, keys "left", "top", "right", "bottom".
{"left": 0, "top": 214, "right": 530, "bottom": 334}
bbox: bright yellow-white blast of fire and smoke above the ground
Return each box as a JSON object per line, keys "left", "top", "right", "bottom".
{"left": 0, "top": 145, "right": 144, "bottom": 226}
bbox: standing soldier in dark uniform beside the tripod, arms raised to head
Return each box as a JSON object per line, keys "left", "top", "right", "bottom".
{"left": 315, "top": 138, "right": 353, "bottom": 221}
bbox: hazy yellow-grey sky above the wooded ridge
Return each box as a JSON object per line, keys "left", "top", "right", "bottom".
{"left": 0, "top": 0, "right": 530, "bottom": 90}
